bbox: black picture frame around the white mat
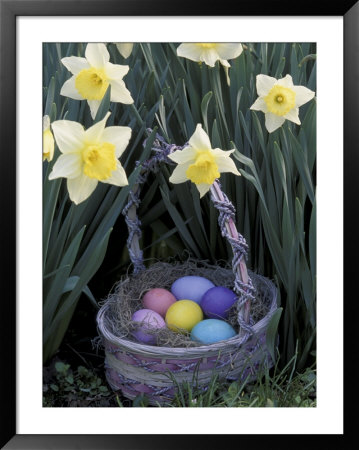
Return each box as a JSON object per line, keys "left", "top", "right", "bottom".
{"left": 0, "top": 0, "right": 359, "bottom": 450}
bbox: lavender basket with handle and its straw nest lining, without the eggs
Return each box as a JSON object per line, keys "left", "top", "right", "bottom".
{"left": 97, "top": 135, "right": 277, "bottom": 405}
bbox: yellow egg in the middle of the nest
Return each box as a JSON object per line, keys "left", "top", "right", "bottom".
{"left": 165, "top": 300, "right": 203, "bottom": 333}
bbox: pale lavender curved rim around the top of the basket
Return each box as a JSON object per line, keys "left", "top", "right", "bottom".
{"left": 96, "top": 272, "right": 278, "bottom": 357}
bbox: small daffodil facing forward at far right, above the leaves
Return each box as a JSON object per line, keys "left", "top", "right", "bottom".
{"left": 251, "top": 75, "right": 315, "bottom": 133}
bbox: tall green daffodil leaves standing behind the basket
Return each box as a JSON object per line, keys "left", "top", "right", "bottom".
{"left": 43, "top": 43, "right": 316, "bottom": 368}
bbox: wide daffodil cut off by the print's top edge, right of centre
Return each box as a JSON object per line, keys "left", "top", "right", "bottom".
{"left": 177, "top": 42, "right": 243, "bottom": 67}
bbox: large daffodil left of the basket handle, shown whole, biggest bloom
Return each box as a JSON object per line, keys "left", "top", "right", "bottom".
{"left": 49, "top": 112, "right": 131, "bottom": 204}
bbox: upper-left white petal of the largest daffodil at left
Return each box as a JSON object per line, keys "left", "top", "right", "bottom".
{"left": 52, "top": 120, "right": 85, "bottom": 153}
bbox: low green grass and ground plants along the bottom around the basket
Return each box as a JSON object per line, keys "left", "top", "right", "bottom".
{"left": 43, "top": 356, "right": 316, "bottom": 408}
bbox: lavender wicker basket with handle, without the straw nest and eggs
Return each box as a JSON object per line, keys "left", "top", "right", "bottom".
{"left": 97, "top": 135, "right": 277, "bottom": 405}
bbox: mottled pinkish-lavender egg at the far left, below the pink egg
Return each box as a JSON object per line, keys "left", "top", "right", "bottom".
{"left": 132, "top": 309, "right": 166, "bottom": 345}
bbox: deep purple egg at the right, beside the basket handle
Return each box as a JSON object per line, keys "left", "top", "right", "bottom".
{"left": 200, "top": 286, "right": 237, "bottom": 319}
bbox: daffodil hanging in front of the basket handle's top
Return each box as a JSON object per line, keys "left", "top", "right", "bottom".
{"left": 168, "top": 124, "right": 240, "bottom": 197}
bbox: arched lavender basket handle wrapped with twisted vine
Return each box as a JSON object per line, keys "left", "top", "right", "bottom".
{"left": 122, "top": 130, "right": 254, "bottom": 333}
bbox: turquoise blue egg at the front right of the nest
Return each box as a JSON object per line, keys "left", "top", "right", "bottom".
{"left": 191, "top": 319, "right": 237, "bottom": 345}
